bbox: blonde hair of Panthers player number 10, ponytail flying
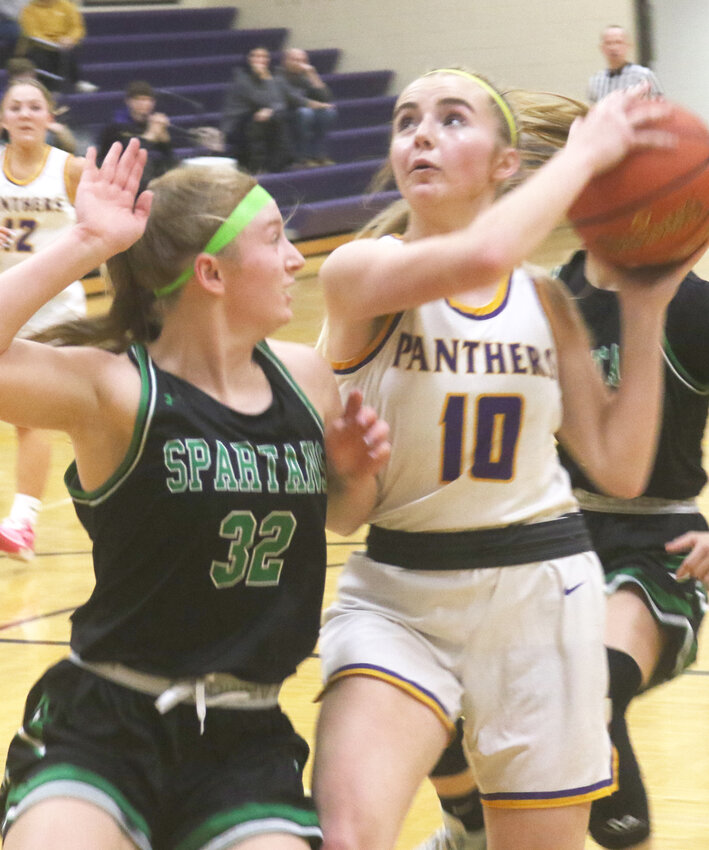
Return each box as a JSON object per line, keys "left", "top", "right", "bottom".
{"left": 357, "top": 67, "right": 589, "bottom": 238}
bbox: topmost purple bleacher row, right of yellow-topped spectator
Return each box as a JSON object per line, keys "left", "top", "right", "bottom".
{"left": 83, "top": 6, "right": 237, "bottom": 36}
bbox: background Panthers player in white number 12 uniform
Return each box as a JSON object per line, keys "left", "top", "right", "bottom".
{"left": 0, "top": 78, "right": 86, "bottom": 560}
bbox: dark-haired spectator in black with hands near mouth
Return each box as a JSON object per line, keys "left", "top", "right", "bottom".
{"left": 97, "top": 80, "right": 177, "bottom": 186}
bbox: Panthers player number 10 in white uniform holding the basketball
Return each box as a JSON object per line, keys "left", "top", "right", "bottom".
{"left": 313, "top": 69, "right": 704, "bottom": 850}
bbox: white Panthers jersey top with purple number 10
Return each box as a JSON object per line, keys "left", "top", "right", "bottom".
{"left": 333, "top": 252, "right": 578, "bottom": 531}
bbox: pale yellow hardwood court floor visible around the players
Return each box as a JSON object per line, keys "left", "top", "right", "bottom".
{"left": 0, "top": 227, "right": 709, "bottom": 850}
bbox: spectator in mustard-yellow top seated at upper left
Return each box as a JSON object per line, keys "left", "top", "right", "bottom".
{"left": 18, "top": 0, "right": 97, "bottom": 91}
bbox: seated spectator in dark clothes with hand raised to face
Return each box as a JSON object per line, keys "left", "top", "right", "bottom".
{"left": 221, "top": 47, "right": 305, "bottom": 174}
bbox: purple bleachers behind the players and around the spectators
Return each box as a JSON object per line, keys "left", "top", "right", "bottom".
{"left": 58, "top": 6, "right": 399, "bottom": 239}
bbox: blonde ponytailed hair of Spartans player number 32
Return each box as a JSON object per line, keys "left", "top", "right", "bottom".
{"left": 35, "top": 165, "right": 256, "bottom": 351}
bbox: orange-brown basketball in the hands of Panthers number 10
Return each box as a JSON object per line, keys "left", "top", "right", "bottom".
{"left": 569, "top": 104, "right": 709, "bottom": 267}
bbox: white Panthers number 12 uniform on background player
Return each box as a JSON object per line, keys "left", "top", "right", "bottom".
{"left": 0, "top": 145, "right": 86, "bottom": 336}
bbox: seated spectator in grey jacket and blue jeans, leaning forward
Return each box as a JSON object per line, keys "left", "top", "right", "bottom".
{"left": 276, "top": 47, "right": 337, "bottom": 165}
